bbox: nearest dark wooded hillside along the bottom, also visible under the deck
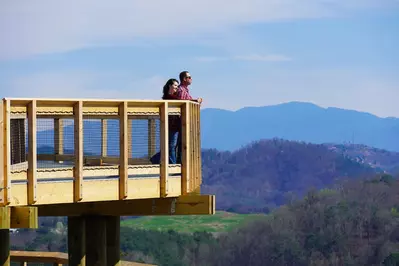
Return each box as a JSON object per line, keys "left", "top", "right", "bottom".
{"left": 11, "top": 175, "right": 399, "bottom": 266}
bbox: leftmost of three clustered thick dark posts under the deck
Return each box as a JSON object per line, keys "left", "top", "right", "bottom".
{"left": 68, "top": 216, "right": 86, "bottom": 266}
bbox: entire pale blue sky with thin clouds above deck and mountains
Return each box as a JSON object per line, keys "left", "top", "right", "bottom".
{"left": 0, "top": 0, "right": 399, "bottom": 117}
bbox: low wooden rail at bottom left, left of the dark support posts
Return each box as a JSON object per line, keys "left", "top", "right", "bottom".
{"left": 10, "top": 250, "right": 68, "bottom": 265}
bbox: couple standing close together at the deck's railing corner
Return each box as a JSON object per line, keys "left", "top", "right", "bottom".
{"left": 162, "top": 71, "right": 202, "bottom": 164}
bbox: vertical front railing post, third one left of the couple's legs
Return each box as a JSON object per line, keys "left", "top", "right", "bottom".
{"left": 73, "top": 101, "right": 83, "bottom": 202}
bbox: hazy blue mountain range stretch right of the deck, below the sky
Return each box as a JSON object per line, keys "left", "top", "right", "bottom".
{"left": 201, "top": 102, "right": 399, "bottom": 151}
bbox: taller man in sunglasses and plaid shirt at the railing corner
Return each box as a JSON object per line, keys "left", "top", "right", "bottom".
{"left": 169, "top": 71, "right": 202, "bottom": 164}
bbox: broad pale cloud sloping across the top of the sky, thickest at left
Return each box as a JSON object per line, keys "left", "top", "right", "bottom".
{"left": 0, "top": 0, "right": 397, "bottom": 60}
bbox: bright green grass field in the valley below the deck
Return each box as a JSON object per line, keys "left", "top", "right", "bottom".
{"left": 121, "top": 211, "right": 265, "bottom": 233}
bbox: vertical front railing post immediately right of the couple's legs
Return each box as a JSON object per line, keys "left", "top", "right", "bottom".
{"left": 181, "top": 102, "right": 191, "bottom": 195}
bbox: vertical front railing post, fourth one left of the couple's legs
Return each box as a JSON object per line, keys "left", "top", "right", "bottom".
{"left": 28, "top": 100, "right": 37, "bottom": 205}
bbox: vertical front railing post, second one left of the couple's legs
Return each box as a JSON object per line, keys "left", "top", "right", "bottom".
{"left": 119, "top": 101, "right": 129, "bottom": 200}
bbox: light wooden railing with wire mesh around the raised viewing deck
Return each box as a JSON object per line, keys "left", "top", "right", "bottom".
{"left": 0, "top": 99, "right": 201, "bottom": 206}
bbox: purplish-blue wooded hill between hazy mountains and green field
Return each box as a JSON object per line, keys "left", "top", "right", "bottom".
{"left": 202, "top": 139, "right": 378, "bottom": 213}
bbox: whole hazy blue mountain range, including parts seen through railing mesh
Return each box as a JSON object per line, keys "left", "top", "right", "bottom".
{"left": 38, "top": 102, "right": 399, "bottom": 153}
